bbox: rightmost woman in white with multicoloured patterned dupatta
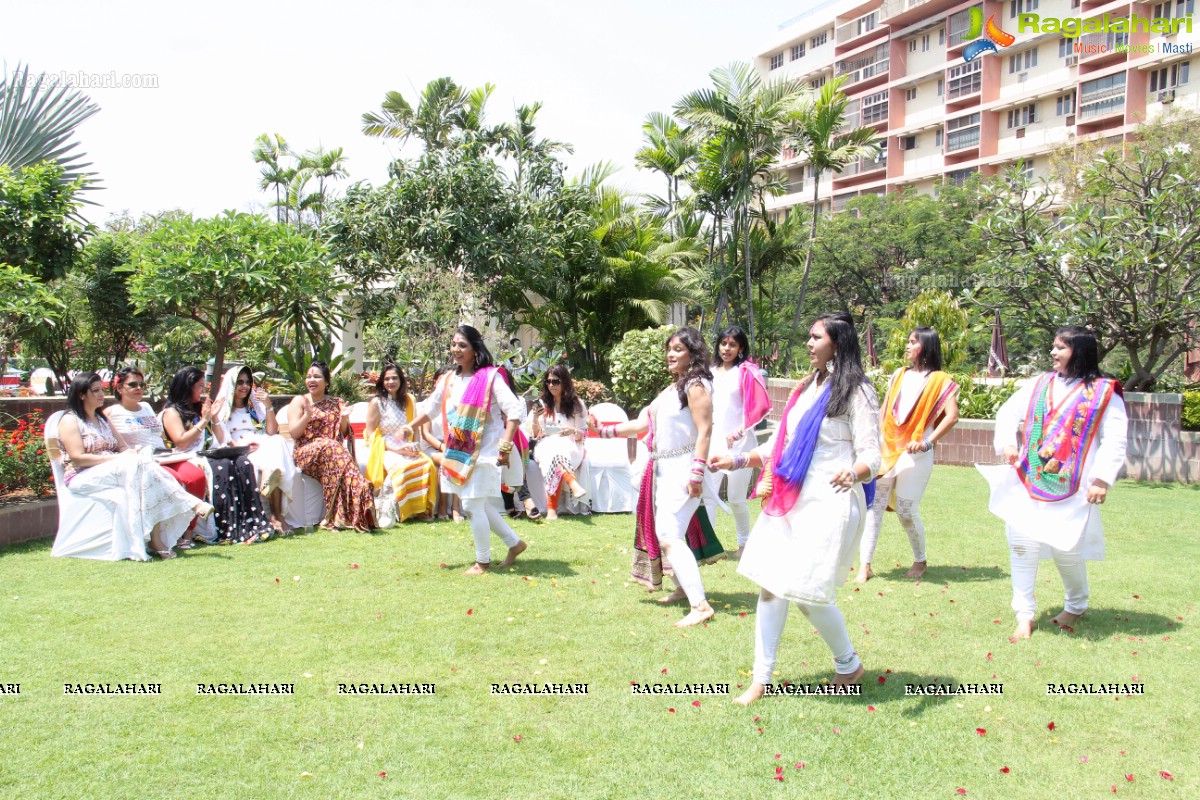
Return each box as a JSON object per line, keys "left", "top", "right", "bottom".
{"left": 977, "top": 325, "right": 1128, "bottom": 639}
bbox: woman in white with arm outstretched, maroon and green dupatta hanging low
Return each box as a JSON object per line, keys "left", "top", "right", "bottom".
{"left": 588, "top": 327, "right": 724, "bottom": 627}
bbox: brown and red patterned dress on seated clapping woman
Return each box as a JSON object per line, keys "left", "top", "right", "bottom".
{"left": 293, "top": 397, "right": 374, "bottom": 530}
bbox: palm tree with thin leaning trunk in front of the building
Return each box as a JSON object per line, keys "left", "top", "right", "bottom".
{"left": 784, "top": 76, "right": 878, "bottom": 367}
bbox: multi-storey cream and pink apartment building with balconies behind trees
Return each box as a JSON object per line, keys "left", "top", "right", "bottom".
{"left": 755, "top": 0, "right": 1200, "bottom": 215}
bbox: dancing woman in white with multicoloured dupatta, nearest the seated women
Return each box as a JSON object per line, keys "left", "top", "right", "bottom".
{"left": 407, "top": 325, "right": 528, "bottom": 575}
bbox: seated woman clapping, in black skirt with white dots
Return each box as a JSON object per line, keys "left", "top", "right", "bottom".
{"left": 162, "top": 367, "right": 272, "bottom": 545}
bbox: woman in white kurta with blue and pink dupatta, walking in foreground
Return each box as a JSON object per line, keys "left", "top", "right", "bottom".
{"left": 710, "top": 312, "right": 880, "bottom": 705}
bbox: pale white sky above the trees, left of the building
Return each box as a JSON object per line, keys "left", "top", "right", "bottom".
{"left": 7, "top": 0, "right": 808, "bottom": 224}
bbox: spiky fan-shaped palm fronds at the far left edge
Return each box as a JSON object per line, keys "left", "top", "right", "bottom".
{"left": 0, "top": 64, "right": 100, "bottom": 190}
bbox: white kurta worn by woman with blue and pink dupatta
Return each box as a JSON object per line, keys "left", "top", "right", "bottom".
{"left": 738, "top": 381, "right": 881, "bottom": 603}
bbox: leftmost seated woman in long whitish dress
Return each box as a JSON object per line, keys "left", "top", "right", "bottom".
{"left": 59, "top": 372, "right": 212, "bottom": 561}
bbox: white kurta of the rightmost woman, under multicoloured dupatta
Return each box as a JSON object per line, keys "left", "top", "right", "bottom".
{"left": 976, "top": 375, "right": 1128, "bottom": 561}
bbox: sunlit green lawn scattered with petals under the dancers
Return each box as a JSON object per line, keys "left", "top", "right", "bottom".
{"left": 0, "top": 468, "right": 1200, "bottom": 800}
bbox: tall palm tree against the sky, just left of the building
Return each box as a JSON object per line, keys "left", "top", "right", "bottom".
{"left": 676, "top": 64, "right": 809, "bottom": 338}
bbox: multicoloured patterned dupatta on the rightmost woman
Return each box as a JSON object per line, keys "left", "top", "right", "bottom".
{"left": 1016, "top": 372, "right": 1116, "bottom": 503}
